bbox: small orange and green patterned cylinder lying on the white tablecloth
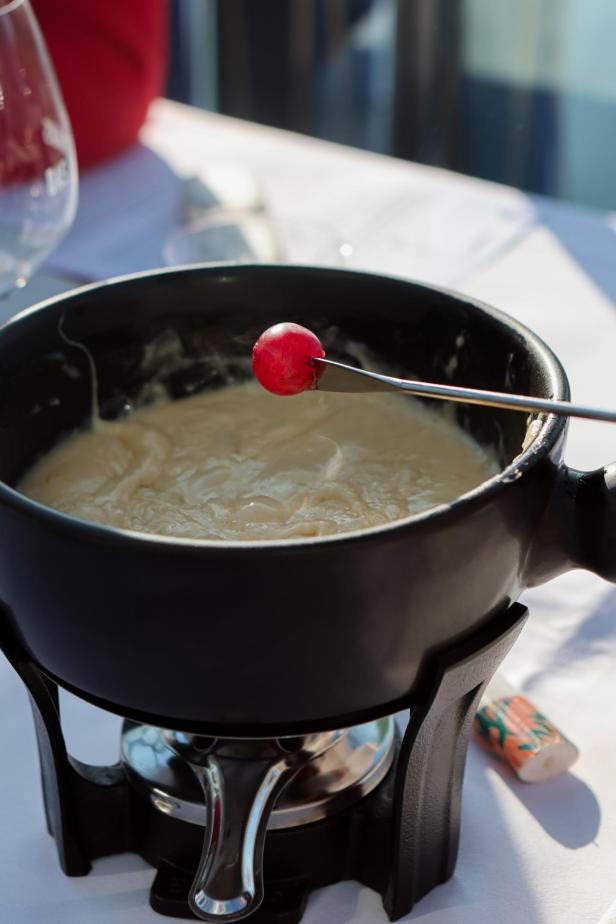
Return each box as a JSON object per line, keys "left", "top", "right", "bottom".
{"left": 473, "top": 676, "right": 579, "bottom": 783}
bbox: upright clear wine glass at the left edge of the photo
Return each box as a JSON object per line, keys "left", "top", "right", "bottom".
{"left": 0, "top": 0, "right": 77, "bottom": 296}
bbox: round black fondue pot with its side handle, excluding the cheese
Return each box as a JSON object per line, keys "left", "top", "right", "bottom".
{"left": 0, "top": 266, "right": 616, "bottom": 737}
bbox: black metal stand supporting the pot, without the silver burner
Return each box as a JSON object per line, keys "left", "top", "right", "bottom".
{"left": 0, "top": 604, "right": 527, "bottom": 924}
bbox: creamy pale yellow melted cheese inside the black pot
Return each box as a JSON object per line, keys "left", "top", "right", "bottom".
{"left": 19, "top": 383, "right": 499, "bottom": 540}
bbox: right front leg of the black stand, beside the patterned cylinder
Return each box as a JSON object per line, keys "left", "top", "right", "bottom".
{"left": 383, "top": 604, "right": 527, "bottom": 921}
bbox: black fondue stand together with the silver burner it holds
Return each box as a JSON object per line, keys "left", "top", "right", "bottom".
{"left": 0, "top": 604, "right": 526, "bottom": 924}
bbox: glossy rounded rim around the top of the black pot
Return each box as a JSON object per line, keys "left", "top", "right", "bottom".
{"left": 0, "top": 262, "right": 569, "bottom": 556}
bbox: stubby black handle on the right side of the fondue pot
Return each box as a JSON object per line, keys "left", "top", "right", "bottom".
{"left": 525, "top": 463, "right": 616, "bottom": 587}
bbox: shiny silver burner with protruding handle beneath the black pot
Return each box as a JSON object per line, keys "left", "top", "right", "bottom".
{"left": 122, "top": 718, "right": 394, "bottom": 920}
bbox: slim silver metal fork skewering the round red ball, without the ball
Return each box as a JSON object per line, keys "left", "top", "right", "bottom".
{"left": 312, "top": 357, "right": 616, "bottom": 423}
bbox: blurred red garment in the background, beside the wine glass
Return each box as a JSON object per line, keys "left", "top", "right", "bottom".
{"left": 32, "top": 0, "right": 169, "bottom": 168}
